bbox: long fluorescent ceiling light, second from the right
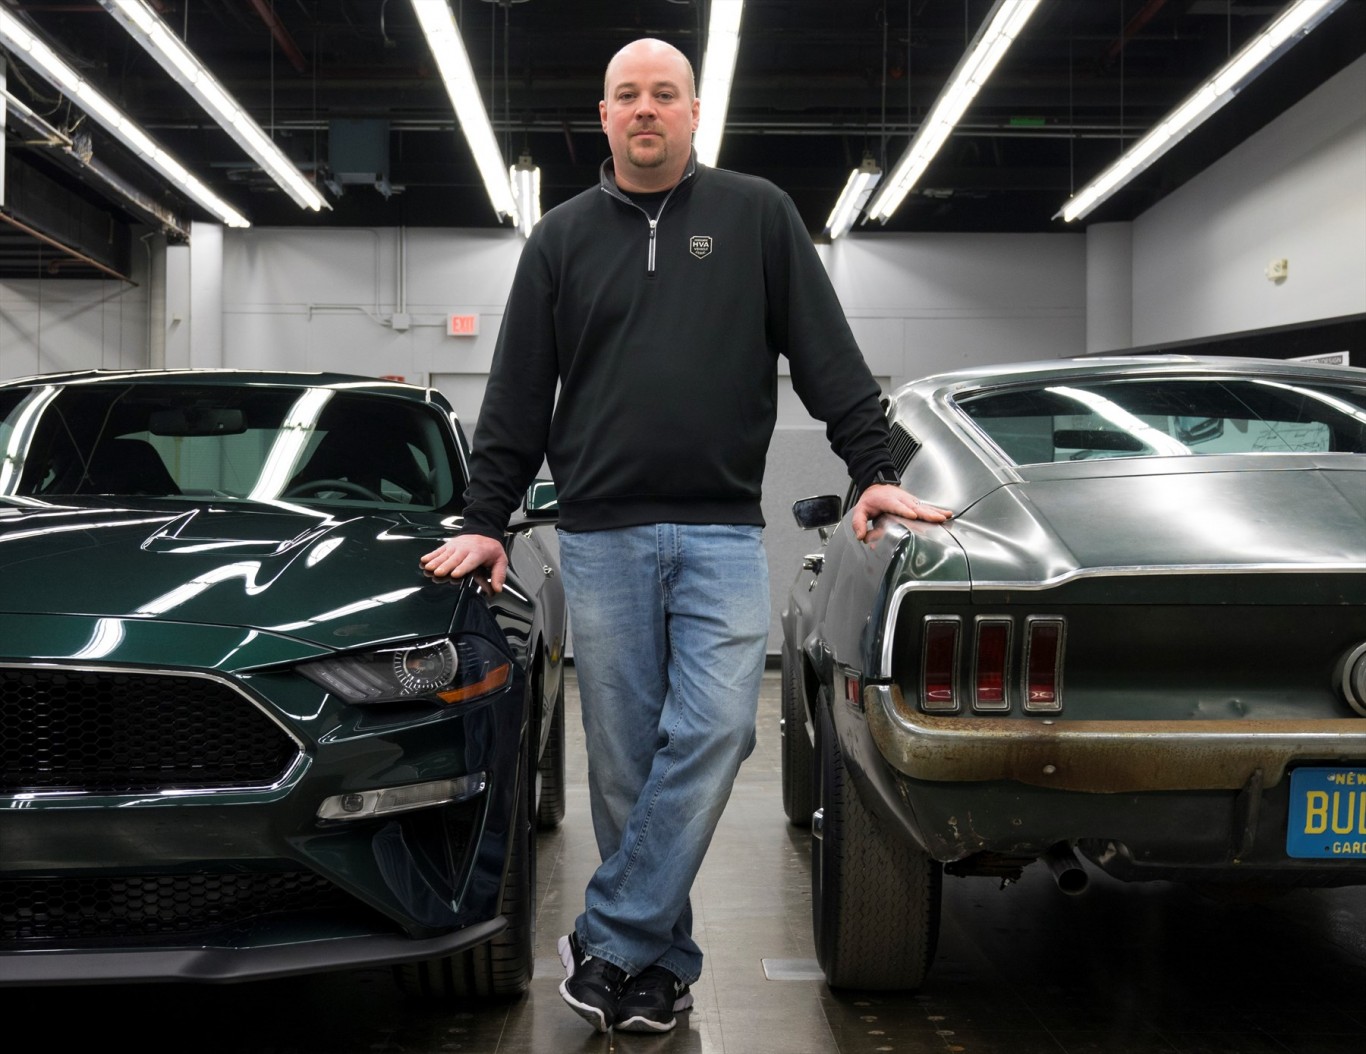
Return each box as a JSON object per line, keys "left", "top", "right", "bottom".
{"left": 867, "top": 0, "right": 1038, "bottom": 223}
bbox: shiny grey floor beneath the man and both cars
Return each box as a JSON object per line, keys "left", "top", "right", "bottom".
{"left": 8, "top": 673, "right": 1366, "bottom": 1054}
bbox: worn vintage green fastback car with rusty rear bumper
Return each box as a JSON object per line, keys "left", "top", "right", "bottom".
{"left": 783, "top": 356, "right": 1366, "bottom": 988}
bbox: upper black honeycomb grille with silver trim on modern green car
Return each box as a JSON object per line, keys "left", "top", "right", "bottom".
{"left": 0, "top": 666, "right": 299, "bottom": 795}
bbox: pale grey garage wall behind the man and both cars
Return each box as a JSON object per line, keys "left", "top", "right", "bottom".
{"left": 0, "top": 60, "right": 1366, "bottom": 649}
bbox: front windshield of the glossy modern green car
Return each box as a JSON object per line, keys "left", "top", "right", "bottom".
{"left": 0, "top": 384, "right": 464, "bottom": 511}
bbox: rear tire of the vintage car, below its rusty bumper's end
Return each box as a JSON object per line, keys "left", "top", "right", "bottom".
{"left": 811, "top": 692, "right": 943, "bottom": 990}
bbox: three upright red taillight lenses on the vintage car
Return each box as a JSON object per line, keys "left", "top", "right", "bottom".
{"left": 919, "top": 614, "right": 1065, "bottom": 714}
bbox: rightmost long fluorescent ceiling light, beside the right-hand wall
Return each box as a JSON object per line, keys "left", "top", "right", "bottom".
{"left": 1053, "top": 0, "right": 1344, "bottom": 223}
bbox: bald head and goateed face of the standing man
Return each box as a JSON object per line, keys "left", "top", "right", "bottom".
{"left": 598, "top": 41, "right": 698, "bottom": 191}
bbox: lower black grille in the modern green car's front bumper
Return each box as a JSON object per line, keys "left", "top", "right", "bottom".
{"left": 0, "top": 871, "right": 388, "bottom": 948}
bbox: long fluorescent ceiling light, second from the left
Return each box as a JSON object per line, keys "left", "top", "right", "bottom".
{"left": 100, "top": 0, "right": 329, "bottom": 210}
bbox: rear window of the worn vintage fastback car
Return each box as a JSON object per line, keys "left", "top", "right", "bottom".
{"left": 956, "top": 377, "right": 1366, "bottom": 464}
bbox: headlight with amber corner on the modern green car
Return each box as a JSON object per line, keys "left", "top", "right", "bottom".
{"left": 299, "top": 636, "right": 512, "bottom": 703}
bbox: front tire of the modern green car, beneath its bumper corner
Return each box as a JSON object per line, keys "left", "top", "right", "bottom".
{"left": 393, "top": 750, "right": 535, "bottom": 999}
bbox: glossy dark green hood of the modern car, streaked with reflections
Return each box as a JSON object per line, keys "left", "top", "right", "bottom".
{"left": 0, "top": 502, "right": 462, "bottom": 649}
